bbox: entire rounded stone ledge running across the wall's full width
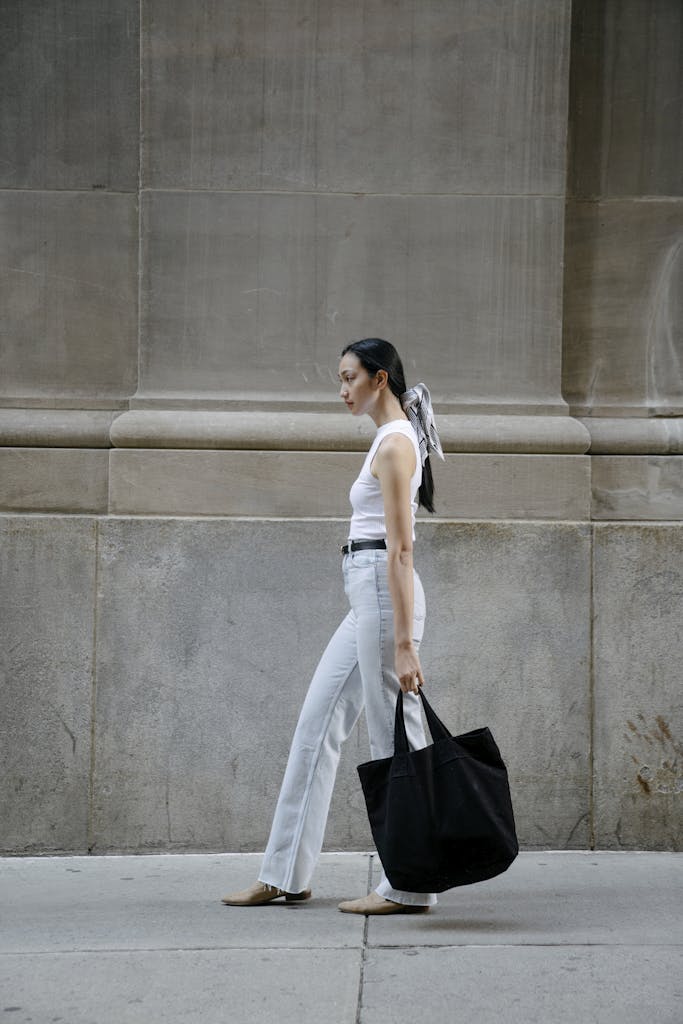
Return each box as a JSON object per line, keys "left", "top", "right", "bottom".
{"left": 7, "top": 406, "right": 683, "bottom": 455}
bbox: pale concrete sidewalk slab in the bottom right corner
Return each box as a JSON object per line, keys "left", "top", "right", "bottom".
{"left": 360, "top": 942, "right": 680, "bottom": 1024}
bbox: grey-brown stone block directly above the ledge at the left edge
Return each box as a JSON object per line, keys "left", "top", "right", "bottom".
{"left": 0, "top": 189, "right": 137, "bottom": 403}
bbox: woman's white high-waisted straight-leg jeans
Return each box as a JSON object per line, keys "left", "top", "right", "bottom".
{"left": 259, "top": 550, "right": 436, "bottom": 906}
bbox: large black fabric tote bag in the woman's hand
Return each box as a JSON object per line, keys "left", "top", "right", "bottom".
{"left": 358, "top": 690, "right": 519, "bottom": 893}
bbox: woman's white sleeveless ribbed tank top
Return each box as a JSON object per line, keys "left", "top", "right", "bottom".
{"left": 348, "top": 420, "right": 422, "bottom": 541}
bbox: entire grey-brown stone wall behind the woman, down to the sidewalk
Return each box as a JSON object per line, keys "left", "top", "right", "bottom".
{"left": 0, "top": 0, "right": 683, "bottom": 852}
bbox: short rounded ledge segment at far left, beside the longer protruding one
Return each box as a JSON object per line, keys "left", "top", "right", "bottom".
{"left": 0, "top": 409, "right": 117, "bottom": 449}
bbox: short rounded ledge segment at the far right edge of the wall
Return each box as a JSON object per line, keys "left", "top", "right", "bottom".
{"left": 581, "top": 416, "right": 683, "bottom": 455}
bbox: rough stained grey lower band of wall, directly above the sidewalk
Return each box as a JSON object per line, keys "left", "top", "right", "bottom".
{"left": 5, "top": 509, "right": 683, "bottom": 852}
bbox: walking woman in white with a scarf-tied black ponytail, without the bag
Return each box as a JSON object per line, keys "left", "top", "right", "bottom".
{"left": 223, "top": 338, "right": 443, "bottom": 914}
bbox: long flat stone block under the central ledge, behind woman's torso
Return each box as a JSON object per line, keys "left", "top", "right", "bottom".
{"left": 110, "top": 449, "right": 591, "bottom": 520}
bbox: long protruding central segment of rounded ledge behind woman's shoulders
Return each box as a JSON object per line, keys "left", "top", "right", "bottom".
{"left": 111, "top": 410, "right": 590, "bottom": 455}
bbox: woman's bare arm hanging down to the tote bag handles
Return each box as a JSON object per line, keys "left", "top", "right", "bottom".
{"left": 372, "top": 434, "right": 424, "bottom": 693}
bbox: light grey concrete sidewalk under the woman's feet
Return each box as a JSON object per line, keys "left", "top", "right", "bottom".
{"left": 0, "top": 852, "right": 683, "bottom": 1024}
